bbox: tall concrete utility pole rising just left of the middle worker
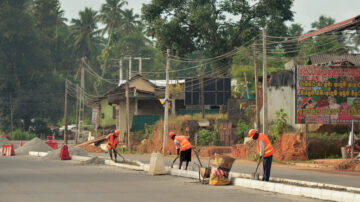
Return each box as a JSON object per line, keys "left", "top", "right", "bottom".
{"left": 163, "top": 49, "right": 170, "bottom": 154}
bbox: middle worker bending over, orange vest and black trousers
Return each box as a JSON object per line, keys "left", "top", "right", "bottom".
{"left": 169, "top": 132, "right": 192, "bottom": 170}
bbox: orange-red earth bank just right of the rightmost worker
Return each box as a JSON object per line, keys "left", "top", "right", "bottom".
{"left": 274, "top": 134, "right": 306, "bottom": 161}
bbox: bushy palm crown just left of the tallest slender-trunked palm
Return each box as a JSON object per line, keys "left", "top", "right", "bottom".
{"left": 71, "top": 8, "right": 99, "bottom": 57}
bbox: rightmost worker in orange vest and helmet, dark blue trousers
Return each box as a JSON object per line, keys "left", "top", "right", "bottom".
{"left": 249, "top": 129, "right": 274, "bottom": 181}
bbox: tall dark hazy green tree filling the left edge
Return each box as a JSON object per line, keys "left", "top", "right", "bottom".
{"left": 0, "top": 0, "right": 57, "bottom": 131}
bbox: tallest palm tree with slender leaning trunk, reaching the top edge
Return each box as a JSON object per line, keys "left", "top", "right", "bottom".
{"left": 100, "top": 0, "right": 127, "bottom": 76}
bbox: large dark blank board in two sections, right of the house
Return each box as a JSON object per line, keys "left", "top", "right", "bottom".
{"left": 185, "top": 78, "right": 231, "bottom": 105}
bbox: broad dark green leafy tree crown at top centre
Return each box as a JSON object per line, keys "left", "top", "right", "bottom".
{"left": 142, "top": 0, "right": 293, "bottom": 57}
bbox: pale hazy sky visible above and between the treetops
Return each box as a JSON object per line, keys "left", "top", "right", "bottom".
{"left": 60, "top": 0, "right": 360, "bottom": 31}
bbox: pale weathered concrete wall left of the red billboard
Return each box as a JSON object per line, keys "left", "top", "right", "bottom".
{"left": 260, "top": 86, "right": 297, "bottom": 128}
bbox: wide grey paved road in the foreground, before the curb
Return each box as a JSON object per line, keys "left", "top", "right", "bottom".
{"left": 0, "top": 156, "right": 315, "bottom": 202}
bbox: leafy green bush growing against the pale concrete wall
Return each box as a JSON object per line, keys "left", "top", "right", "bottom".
{"left": 269, "top": 108, "right": 287, "bottom": 143}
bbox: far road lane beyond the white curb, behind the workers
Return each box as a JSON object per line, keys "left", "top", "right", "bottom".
{"left": 93, "top": 154, "right": 360, "bottom": 188}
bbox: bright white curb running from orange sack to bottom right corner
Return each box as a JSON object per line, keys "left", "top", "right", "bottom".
{"left": 232, "top": 178, "right": 360, "bottom": 202}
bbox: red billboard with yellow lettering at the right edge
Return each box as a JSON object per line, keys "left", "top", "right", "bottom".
{"left": 295, "top": 65, "right": 360, "bottom": 124}
